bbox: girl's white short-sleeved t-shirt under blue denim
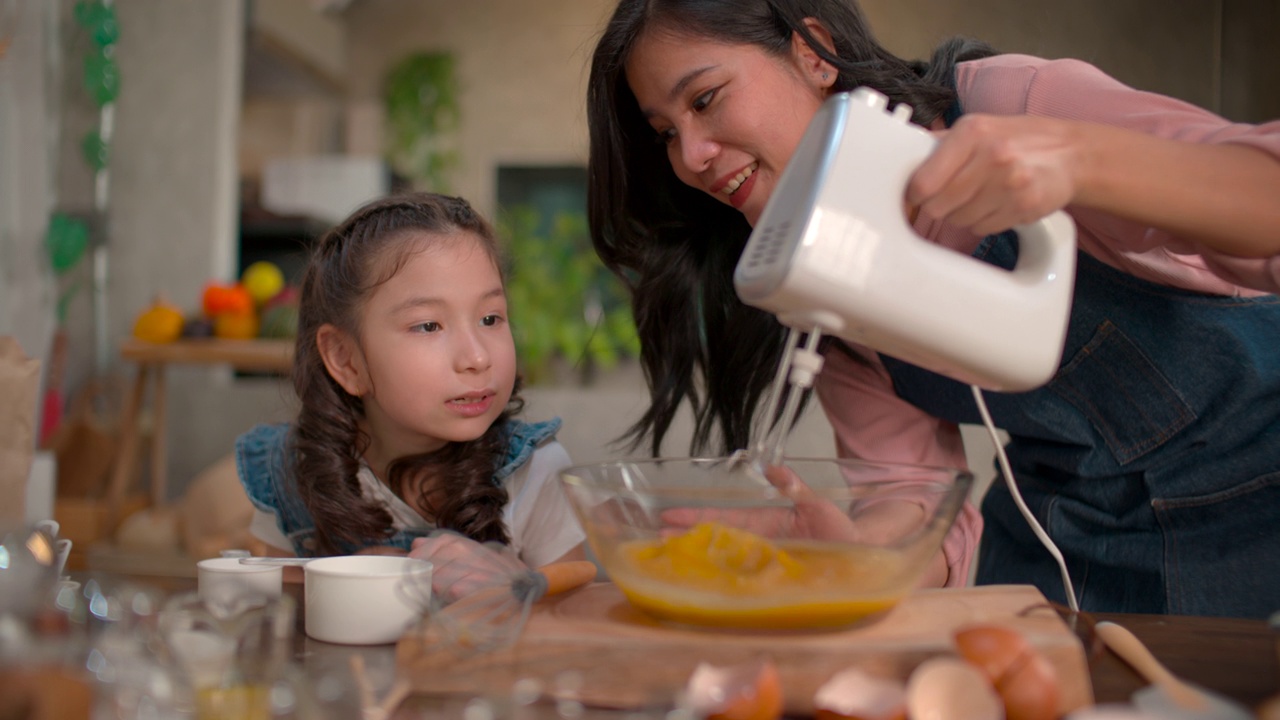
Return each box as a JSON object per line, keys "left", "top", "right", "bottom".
{"left": 250, "top": 439, "right": 586, "bottom": 568}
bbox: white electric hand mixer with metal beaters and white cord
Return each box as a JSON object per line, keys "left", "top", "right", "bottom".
{"left": 733, "top": 88, "right": 1076, "bottom": 610}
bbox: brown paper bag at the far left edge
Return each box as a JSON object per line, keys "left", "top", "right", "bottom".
{"left": 0, "top": 336, "right": 40, "bottom": 525}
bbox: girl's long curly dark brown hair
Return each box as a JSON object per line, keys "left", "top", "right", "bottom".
{"left": 291, "top": 193, "right": 524, "bottom": 555}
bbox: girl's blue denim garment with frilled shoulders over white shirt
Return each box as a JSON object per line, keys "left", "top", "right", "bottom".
{"left": 236, "top": 418, "right": 561, "bottom": 557}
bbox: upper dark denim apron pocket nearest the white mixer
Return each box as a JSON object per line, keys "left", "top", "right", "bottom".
{"left": 1048, "top": 320, "right": 1196, "bottom": 465}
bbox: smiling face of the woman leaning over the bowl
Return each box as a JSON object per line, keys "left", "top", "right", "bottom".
{"left": 626, "top": 32, "right": 836, "bottom": 225}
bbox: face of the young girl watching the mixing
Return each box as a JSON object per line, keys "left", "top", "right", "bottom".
{"left": 350, "top": 233, "right": 516, "bottom": 459}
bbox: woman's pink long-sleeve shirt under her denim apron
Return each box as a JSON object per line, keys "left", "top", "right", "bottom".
{"left": 817, "top": 55, "right": 1280, "bottom": 585}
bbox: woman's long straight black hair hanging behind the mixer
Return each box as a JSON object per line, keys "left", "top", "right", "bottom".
{"left": 588, "top": 0, "right": 995, "bottom": 456}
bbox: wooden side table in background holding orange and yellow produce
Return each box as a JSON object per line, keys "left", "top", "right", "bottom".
{"left": 106, "top": 338, "right": 293, "bottom": 529}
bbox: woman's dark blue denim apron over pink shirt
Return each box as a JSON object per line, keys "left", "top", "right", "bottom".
{"left": 883, "top": 233, "right": 1280, "bottom": 618}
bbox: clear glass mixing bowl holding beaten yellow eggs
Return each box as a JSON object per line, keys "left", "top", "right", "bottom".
{"left": 561, "top": 459, "right": 973, "bottom": 630}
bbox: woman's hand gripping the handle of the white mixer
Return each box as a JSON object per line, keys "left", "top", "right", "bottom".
{"left": 905, "top": 114, "right": 1080, "bottom": 236}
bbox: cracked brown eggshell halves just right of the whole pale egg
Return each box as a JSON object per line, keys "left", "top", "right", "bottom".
{"left": 955, "top": 624, "right": 1061, "bottom": 720}
